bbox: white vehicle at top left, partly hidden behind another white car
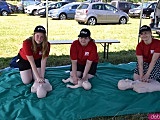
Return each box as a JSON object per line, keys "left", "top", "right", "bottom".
{"left": 17, "top": 0, "right": 41, "bottom": 13}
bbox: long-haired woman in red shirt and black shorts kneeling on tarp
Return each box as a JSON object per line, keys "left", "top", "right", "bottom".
{"left": 16, "top": 26, "right": 50, "bottom": 84}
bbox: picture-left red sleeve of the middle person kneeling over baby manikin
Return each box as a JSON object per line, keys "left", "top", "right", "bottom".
{"left": 70, "top": 41, "right": 78, "bottom": 60}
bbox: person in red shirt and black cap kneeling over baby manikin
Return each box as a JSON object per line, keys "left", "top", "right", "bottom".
{"left": 70, "top": 28, "right": 99, "bottom": 89}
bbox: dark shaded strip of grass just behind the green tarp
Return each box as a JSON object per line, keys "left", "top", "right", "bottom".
{"left": 0, "top": 50, "right": 136, "bottom": 69}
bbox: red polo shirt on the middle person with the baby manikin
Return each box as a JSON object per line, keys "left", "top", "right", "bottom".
{"left": 70, "top": 40, "right": 99, "bottom": 65}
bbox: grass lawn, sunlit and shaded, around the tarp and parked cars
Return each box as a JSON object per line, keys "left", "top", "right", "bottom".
{"left": 0, "top": 14, "right": 158, "bottom": 120}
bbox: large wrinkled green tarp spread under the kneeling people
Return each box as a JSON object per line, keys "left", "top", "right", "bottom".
{"left": 0, "top": 63, "right": 160, "bottom": 120}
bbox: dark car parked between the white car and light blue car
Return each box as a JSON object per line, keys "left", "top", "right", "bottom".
{"left": 37, "top": 1, "right": 70, "bottom": 17}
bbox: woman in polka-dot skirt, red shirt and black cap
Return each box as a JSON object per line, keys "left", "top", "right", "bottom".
{"left": 133, "top": 25, "right": 160, "bottom": 82}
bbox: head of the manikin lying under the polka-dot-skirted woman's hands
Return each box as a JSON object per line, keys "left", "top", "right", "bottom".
{"left": 118, "top": 79, "right": 133, "bottom": 90}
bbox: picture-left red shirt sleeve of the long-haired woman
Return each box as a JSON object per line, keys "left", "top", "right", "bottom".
{"left": 23, "top": 40, "right": 33, "bottom": 56}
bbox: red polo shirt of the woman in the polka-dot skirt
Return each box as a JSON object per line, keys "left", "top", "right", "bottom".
{"left": 136, "top": 39, "right": 160, "bottom": 63}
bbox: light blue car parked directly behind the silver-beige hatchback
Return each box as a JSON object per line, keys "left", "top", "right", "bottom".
{"left": 49, "top": 2, "right": 81, "bottom": 20}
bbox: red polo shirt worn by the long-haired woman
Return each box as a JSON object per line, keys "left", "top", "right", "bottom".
{"left": 19, "top": 40, "right": 50, "bottom": 60}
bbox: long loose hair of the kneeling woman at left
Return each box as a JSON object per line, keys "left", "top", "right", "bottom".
{"left": 27, "top": 33, "right": 49, "bottom": 59}
